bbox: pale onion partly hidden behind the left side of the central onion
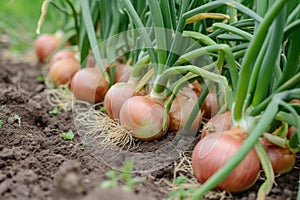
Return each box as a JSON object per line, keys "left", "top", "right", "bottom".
{"left": 104, "top": 82, "right": 138, "bottom": 119}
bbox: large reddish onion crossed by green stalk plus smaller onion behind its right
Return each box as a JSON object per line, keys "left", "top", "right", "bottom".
{"left": 192, "top": 111, "right": 296, "bottom": 192}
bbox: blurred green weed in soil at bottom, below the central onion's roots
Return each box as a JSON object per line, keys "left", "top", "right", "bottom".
{"left": 101, "top": 160, "right": 144, "bottom": 192}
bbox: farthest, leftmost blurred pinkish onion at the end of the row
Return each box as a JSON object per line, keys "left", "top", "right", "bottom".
{"left": 34, "top": 34, "right": 60, "bottom": 62}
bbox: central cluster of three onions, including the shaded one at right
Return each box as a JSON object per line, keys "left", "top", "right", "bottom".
{"left": 104, "top": 69, "right": 206, "bottom": 141}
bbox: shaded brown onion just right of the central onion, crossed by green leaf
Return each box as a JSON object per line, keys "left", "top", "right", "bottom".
{"left": 167, "top": 87, "right": 202, "bottom": 133}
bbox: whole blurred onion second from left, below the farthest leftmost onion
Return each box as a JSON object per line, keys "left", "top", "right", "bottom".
{"left": 49, "top": 58, "right": 80, "bottom": 85}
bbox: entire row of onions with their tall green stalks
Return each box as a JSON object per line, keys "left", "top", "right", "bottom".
{"left": 36, "top": 0, "right": 300, "bottom": 199}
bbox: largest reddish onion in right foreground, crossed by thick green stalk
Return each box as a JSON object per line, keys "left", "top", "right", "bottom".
{"left": 192, "top": 128, "right": 260, "bottom": 192}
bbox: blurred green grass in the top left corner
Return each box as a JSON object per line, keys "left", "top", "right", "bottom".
{"left": 0, "top": 0, "right": 64, "bottom": 54}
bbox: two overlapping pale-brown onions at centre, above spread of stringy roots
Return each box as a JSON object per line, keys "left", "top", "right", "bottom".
{"left": 104, "top": 74, "right": 167, "bottom": 141}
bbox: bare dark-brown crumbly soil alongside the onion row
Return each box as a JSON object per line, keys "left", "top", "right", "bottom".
{"left": 0, "top": 48, "right": 300, "bottom": 200}
